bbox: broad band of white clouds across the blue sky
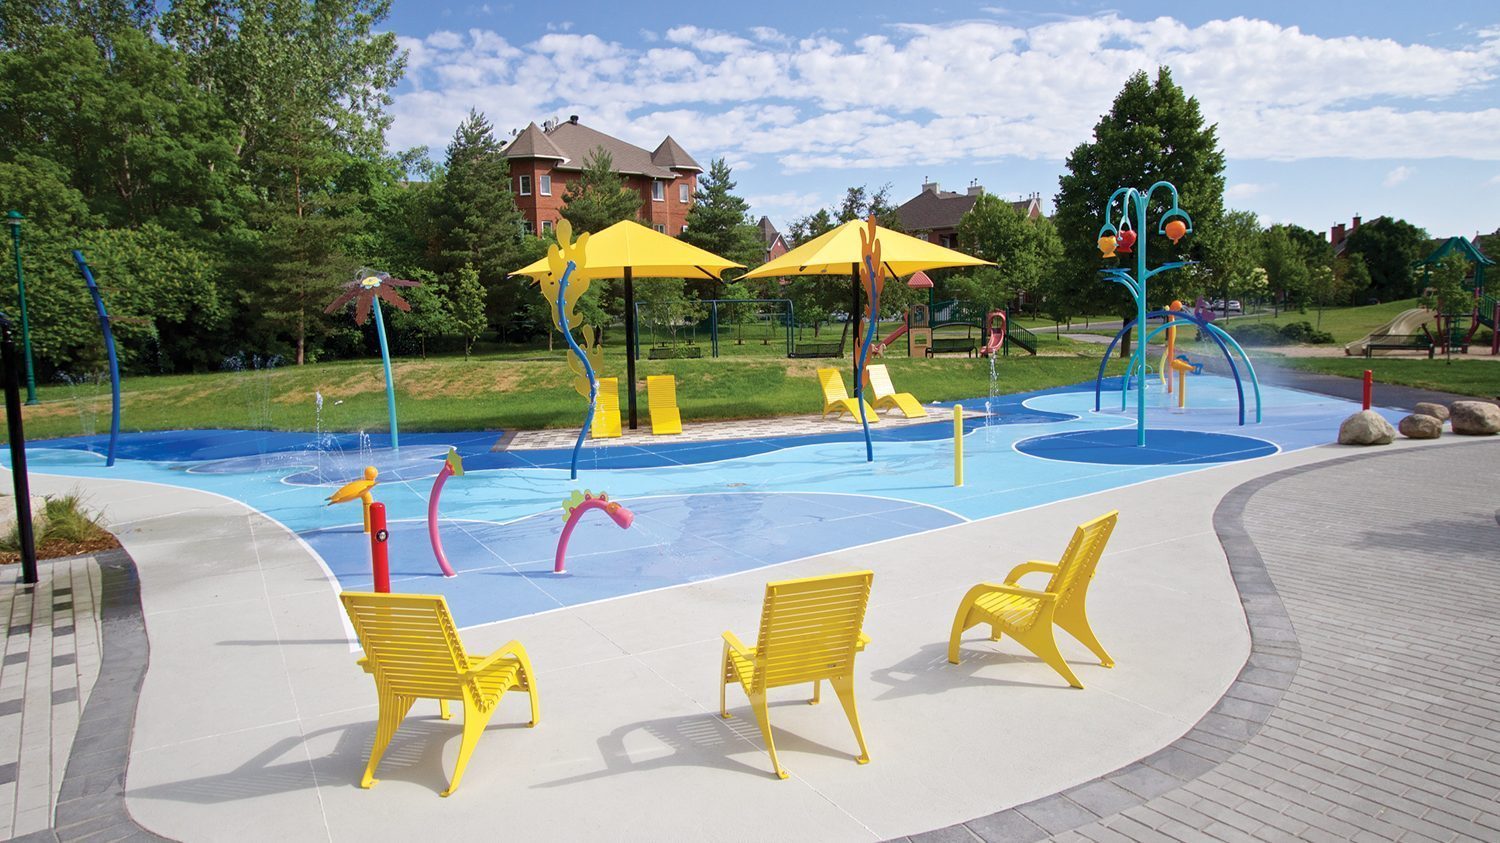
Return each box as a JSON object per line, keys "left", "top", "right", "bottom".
{"left": 390, "top": 15, "right": 1500, "bottom": 165}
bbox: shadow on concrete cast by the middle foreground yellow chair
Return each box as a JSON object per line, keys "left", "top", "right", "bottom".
{"left": 537, "top": 686, "right": 858, "bottom": 788}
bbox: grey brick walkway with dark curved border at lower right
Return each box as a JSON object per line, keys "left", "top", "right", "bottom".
{"left": 917, "top": 441, "right": 1500, "bottom": 842}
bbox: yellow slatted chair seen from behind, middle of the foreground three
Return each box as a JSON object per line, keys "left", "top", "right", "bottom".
{"left": 719, "top": 572, "right": 875, "bottom": 779}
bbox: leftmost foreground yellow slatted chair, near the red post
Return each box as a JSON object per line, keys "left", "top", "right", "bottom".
{"left": 339, "top": 591, "right": 542, "bottom": 797}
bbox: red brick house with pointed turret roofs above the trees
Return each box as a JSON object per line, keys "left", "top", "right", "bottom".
{"left": 504, "top": 114, "right": 704, "bottom": 237}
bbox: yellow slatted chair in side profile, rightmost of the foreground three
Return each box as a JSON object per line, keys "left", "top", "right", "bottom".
{"left": 948, "top": 510, "right": 1119, "bottom": 689}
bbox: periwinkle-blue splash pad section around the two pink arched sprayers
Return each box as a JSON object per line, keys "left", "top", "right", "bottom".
{"left": 300, "top": 492, "right": 963, "bottom": 627}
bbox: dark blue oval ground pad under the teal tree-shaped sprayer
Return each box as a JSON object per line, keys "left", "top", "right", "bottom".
{"left": 1016, "top": 428, "right": 1277, "bottom": 465}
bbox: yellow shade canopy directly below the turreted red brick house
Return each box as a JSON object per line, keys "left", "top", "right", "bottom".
{"left": 510, "top": 219, "right": 747, "bottom": 279}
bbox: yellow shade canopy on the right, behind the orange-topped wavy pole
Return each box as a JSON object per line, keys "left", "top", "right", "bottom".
{"left": 741, "top": 219, "right": 993, "bottom": 278}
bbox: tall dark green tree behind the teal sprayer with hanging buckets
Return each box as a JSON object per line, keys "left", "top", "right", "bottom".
{"left": 1053, "top": 68, "right": 1224, "bottom": 356}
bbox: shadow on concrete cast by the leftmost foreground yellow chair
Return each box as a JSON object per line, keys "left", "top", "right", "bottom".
{"left": 126, "top": 701, "right": 527, "bottom": 804}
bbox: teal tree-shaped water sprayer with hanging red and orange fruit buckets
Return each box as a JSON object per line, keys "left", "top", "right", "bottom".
{"left": 1100, "top": 182, "right": 1193, "bottom": 447}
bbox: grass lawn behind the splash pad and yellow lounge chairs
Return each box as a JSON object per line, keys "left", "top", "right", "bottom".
{"left": 5, "top": 341, "right": 1119, "bottom": 440}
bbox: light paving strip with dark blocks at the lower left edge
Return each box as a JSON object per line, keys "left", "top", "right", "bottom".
{"left": 0, "top": 555, "right": 101, "bottom": 839}
